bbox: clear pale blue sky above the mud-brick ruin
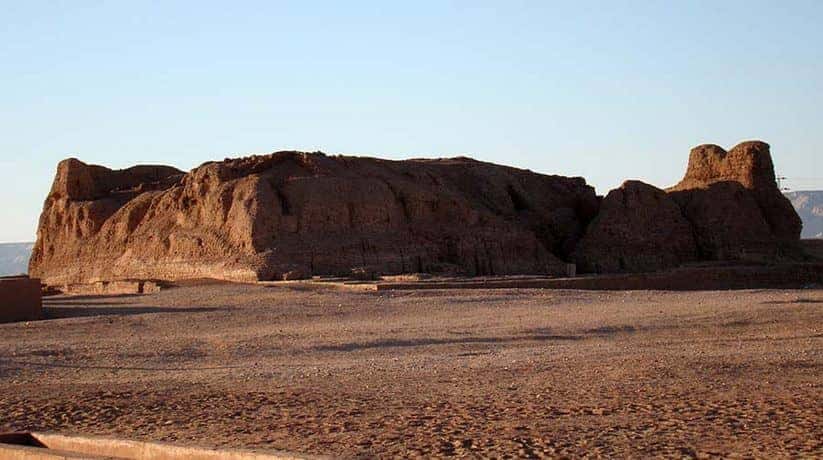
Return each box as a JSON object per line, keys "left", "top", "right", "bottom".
{"left": 0, "top": 0, "right": 823, "bottom": 241}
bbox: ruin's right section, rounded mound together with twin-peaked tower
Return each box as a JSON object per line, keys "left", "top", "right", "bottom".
{"left": 577, "top": 141, "right": 803, "bottom": 272}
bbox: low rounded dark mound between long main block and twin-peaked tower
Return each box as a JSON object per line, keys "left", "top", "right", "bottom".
{"left": 577, "top": 181, "right": 697, "bottom": 273}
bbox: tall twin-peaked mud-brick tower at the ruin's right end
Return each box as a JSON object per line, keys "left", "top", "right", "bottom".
{"left": 668, "top": 141, "right": 802, "bottom": 260}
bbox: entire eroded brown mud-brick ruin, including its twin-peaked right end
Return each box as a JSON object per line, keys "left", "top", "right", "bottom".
{"left": 30, "top": 141, "right": 801, "bottom": 285}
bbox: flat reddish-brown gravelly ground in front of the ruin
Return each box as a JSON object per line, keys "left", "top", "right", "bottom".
{"left": 0, "top": 284, "right": 823, "bottom": 457}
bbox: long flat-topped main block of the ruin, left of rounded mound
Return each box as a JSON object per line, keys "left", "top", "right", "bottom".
{"left": 30, "top": 152, "right": 598, "bottom": 284}
